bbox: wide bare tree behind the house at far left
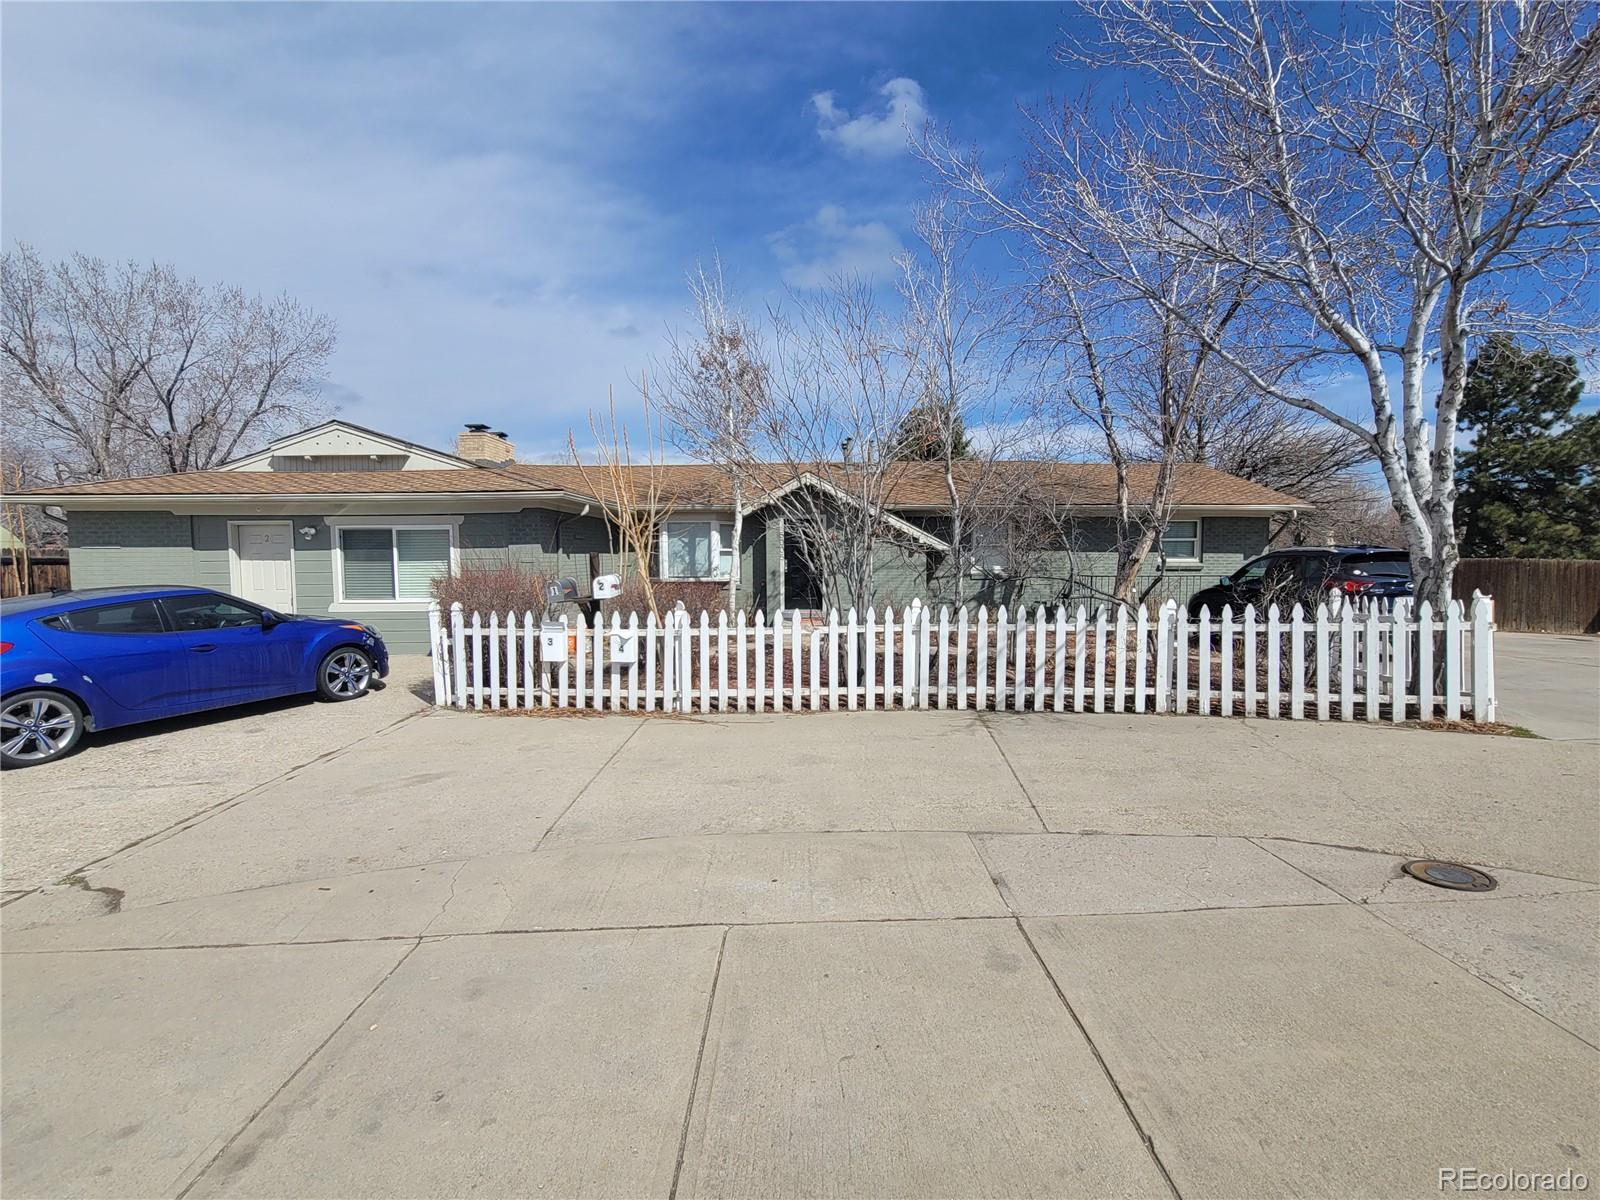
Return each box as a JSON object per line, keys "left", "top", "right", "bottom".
{"left": 0, "top": 246, "right": 334, "bottom": 482}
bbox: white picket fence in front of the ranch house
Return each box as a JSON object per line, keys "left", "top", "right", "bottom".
{"left": 429, "top": 595, "right": 1494, "bottom": 722}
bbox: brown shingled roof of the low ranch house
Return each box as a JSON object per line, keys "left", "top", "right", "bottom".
{"left": 13, "top": 462, "right": 1307, "bottom": 509}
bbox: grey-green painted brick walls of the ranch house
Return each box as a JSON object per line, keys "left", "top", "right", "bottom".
{"left": 67, "top": 509, "right": 1269, "bottom": 654}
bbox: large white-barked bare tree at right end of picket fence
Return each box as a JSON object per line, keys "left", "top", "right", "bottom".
{"left": 930, "top": 0, "right": 1600, "bottom": 603}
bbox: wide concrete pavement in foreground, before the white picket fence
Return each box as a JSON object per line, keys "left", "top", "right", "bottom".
{"left": 0, "top": 706, "right": 1600, "bottom": 1197}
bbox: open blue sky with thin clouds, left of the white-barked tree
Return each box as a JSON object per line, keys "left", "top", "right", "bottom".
{"left": 0, "top": 3, "right": 1077, "bottom": 454}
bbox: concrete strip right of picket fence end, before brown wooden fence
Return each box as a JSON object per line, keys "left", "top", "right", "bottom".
{"left": 1494, "top": 634, "right": 1600, "bottom": 742}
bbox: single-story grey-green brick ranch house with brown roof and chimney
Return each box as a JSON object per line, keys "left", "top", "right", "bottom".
{"left": 11, "top": 421, "right": 1306, "bottom": 653}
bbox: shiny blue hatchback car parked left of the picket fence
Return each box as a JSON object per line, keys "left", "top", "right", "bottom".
{"left": 0, "top": 587, "right": 389, "bottom": 766}
